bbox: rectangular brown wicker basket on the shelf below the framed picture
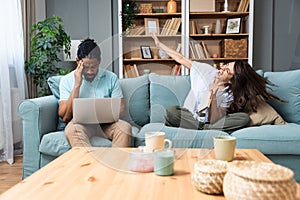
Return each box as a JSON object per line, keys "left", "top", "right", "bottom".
{"left": 221, "top": 39, "right": 248, "bottom": 58}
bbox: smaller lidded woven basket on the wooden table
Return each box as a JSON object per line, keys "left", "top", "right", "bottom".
{"left": 191, "top": 160, "right": 227, "bottom": 194}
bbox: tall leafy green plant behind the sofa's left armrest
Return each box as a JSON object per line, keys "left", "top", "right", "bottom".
{"left": 25, "top": 15, "right": 71, "bottom": 96}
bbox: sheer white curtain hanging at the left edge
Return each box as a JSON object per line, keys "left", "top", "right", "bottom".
{"left": 0, "top": 0, "right": 26, "bottom": 164}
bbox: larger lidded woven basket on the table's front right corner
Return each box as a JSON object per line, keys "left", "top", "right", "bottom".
{"left": 223, "top": 161, "right": 297, "bottom": 200}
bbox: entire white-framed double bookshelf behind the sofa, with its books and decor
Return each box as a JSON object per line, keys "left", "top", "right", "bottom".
{"left": 119, "top": 0, "right": 254, "bottom": 78}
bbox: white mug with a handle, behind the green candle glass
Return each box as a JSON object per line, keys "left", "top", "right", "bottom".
{"left": 145, "top": 132, "right": 172, "bottom": 151}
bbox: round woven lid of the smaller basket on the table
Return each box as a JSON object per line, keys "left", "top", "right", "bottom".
{"left": 194, "top": 160, "right": 227, "bottom": 174}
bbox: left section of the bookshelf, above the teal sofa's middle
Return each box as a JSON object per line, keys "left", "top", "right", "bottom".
{"left": 119, "top": 0, "right": 185, "bottom": 78}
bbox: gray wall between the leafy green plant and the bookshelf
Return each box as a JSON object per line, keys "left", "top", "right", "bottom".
{"left": 46, "top": 0, "right": 113, "bottom": 70}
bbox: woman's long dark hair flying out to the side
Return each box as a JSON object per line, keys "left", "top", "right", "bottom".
{"left": 227, "top": 60, "right": 282, "bottom": 113}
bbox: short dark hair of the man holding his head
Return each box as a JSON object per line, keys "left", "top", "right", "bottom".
{"left": 77, "top": 38, "right": 101, "bottom": 60}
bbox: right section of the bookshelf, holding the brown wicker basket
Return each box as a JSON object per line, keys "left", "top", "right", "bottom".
{"left": 185, "top": 0, "right": 254, "bottom": 67}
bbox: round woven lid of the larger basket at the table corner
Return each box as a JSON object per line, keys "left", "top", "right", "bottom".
{"left": 228, "top": 161, "right": 294, "bottom": 182}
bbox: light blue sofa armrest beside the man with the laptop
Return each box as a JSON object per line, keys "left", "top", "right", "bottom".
{"left": 18, "top": 95, "right": 58, "bottom": 178}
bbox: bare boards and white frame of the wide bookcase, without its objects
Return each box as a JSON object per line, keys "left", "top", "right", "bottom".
{"left": 119, "top": 0, "right": 254, "bottom": 78}
